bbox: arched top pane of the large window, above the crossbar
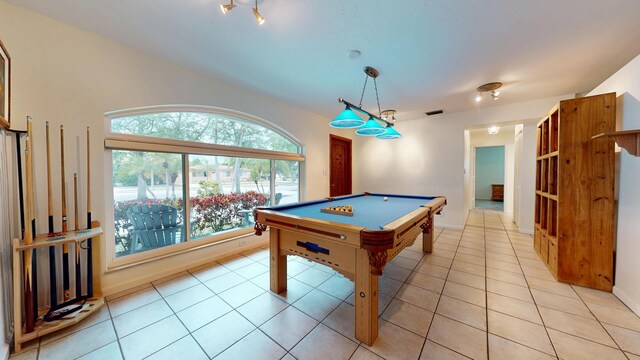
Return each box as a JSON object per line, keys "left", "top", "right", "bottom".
{"left": 106, "top": 106, "right": 302, "bottom": 154}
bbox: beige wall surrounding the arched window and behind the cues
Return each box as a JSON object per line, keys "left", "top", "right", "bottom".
{"left": 0, "top": 0, "right": 360, "bottom": 312}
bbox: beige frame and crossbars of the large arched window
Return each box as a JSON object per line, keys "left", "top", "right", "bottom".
{"left": 103, "top": 105, "right": 306, "bottom": 272}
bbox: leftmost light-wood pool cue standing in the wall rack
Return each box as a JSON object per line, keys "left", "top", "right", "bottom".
{"left": 22, "top": 118, "right": 36, "bottom": 333}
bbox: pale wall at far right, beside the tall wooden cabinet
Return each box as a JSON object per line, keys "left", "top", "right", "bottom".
{"left": 589, "top": 56, "right": 640, "bottom": 315}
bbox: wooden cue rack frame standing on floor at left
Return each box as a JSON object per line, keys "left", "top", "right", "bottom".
{"left": 12, "top": 225, "right": 104, "bottom": 353}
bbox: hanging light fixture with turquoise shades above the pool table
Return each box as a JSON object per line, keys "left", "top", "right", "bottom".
{"left": 329, "top": 66, "right": 402, "bottom": 139}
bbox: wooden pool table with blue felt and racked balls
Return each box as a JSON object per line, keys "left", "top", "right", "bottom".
{"left": 254, "top": 193, "right": 447, "bottom": 345}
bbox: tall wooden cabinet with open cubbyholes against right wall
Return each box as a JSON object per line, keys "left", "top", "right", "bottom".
{"left": 534, "top": 93, "right": 616, "bottom": 291}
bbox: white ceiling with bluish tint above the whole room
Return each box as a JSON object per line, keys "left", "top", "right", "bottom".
{"left": 9, "top": 0, "right": 640, "bottom": 120}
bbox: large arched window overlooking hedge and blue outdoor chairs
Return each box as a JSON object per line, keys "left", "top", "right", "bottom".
{"left": 105, "top": 107, "right": 304, "bottom": 257}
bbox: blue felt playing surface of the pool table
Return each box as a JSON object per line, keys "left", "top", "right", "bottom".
{"left": 269, "top": 194, "right": 435, "bottom": 230}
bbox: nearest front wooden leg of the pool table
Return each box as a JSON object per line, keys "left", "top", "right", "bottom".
{"left": 354, "top": 249, "right": 378, "bottom": 346}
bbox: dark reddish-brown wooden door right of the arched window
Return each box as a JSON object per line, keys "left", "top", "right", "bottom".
{"left": 329, "top": 134, "right": 351, "bottom": 196}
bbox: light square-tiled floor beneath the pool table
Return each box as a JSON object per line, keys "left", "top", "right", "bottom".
{"left": 12, "top": 210, "right": 640, "bottom": 360}
